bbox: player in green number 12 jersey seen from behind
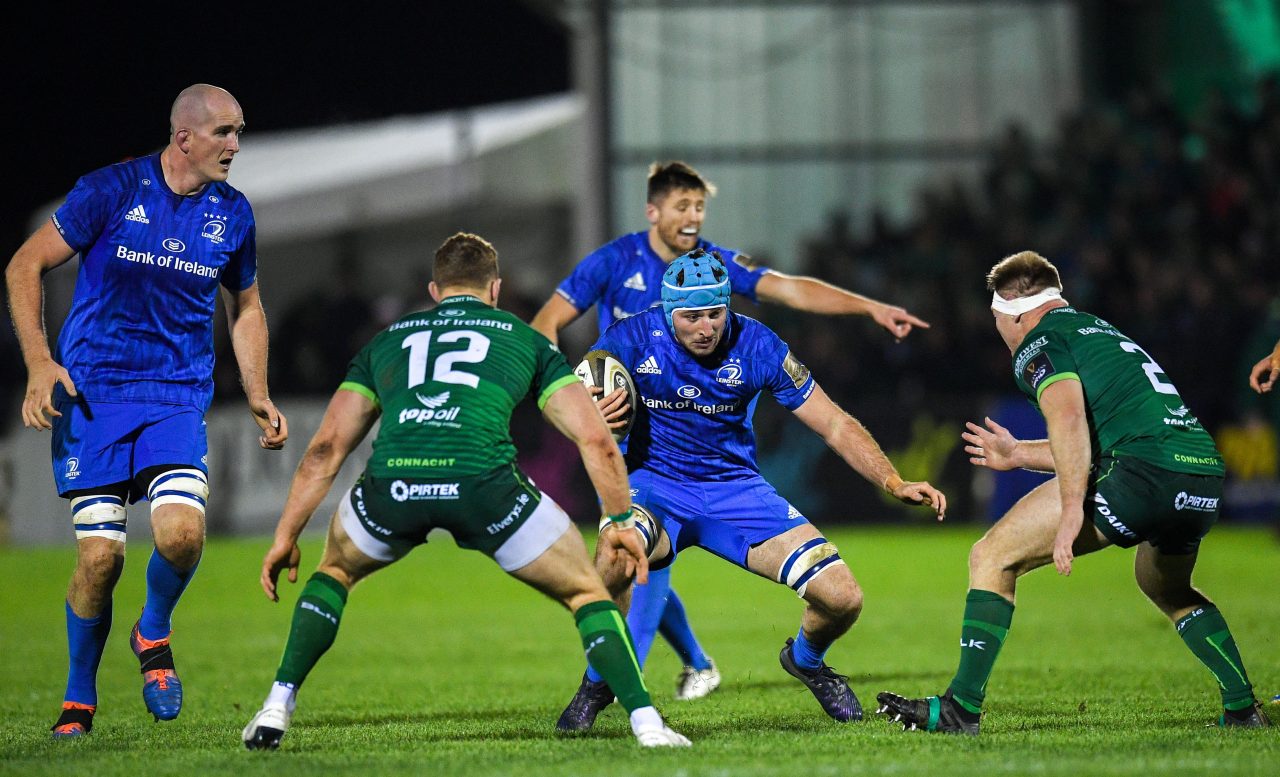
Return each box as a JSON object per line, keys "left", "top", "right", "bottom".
{"left": 243, "top": 233, "right": 689, "bottom": 750}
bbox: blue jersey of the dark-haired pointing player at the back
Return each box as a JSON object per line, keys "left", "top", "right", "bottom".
{"left": 556, "top": 232, "right": 768, "bottom": 334}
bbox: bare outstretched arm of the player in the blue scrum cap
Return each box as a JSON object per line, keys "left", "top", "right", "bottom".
{"left": 795, "top": 384, "right": 947, "bottom": 521}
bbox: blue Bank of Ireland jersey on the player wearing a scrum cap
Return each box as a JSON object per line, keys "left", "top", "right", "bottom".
{"left": 593, "top": 307, "right": 814, "bottom": 480}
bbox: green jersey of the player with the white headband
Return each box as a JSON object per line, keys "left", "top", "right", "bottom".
{"left": 1014, "top": 307, "right": 1225, "bottom": 476}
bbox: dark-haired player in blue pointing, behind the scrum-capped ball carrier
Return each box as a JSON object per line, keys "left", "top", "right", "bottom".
{"left": 532, "top": 161, "right": 928, "bottom": 699}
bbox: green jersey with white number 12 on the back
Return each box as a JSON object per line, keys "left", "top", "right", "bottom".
{"left": 338, "top": 296, "right": 577, "bottom": 477}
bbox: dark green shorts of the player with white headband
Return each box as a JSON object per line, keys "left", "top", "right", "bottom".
{"left": 1091, "top": 457, "right": 1222, "bottom": 556}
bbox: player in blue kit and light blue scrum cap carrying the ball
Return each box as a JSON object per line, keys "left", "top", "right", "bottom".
{"left": 557, "top": 250, "right": 946, "bottom": 731}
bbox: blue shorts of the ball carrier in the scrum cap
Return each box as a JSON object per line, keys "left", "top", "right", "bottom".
{"left": 631, "top": 470, "right": 809, "bottom": 570}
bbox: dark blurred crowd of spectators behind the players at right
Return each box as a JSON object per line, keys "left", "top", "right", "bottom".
{"left": 783, "top": 77, "right": 1280, "bottom": 431}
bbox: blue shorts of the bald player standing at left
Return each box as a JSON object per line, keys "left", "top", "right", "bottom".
{"left": 51, "top": 399, "right": 209, "bottom": 503}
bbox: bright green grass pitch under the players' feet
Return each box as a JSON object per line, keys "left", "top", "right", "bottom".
{"left": 0, "top": 526, "right": 1280, "bottom": 777}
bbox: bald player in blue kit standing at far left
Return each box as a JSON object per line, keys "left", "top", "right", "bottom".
{"left": 5, "top": 84, "right": 288, "bottom": 739}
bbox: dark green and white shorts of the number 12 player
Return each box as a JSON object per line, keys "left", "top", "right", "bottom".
{"left": 338, "top": 463, "right": 571, "bottom": 572}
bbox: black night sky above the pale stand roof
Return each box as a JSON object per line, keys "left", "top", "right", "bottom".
{"left": 0, "top": 0, "right": 570, "bottom": 256}
